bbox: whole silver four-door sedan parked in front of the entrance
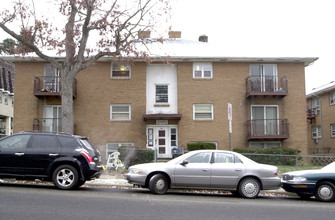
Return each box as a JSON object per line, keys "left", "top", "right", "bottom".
{"left": 125, "top": 150, "right": 280, "bottom": 198}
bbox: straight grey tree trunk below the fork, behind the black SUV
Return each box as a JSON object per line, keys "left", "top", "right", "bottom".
{"left": 61, "top": 70, "right": 74, "bottom": 134}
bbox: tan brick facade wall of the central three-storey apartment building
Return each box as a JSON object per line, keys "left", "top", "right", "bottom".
{"left": 14, "top": 62, "right": 307, "bottom": 155}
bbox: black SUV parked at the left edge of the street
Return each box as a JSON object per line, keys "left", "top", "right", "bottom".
{"left": 0, "top": 132, "right": 103, "bottom": 189}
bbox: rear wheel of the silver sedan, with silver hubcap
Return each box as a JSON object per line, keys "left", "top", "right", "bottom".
{"left": 238, "top": 177, "right": 260, "bottom": 199}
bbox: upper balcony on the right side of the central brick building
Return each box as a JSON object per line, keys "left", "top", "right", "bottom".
{"left": 246, "top": 76, "right": 288, "bottom": 99}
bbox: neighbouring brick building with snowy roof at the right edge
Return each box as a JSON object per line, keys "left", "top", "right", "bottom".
{"left": 306, "top": 81, "right": 335, "bottom": 155}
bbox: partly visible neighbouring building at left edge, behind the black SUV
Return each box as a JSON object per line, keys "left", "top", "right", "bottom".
{"left": 0, "top": 59, "right": 14, "bottom": 137}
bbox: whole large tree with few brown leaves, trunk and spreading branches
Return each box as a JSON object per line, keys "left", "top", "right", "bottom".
{"left": 0, "top": 0, "right": 170, "bottom": 133}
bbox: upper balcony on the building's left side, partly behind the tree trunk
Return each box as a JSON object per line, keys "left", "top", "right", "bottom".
{"left": 34, "top": 76, "right": 77, "bottom": 98}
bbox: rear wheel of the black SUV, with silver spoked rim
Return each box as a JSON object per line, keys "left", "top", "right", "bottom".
{"left": 52, "top": 165, "right": 79, "bottom": 189}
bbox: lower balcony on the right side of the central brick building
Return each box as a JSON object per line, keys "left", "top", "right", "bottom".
{"left": 247, "top": 119, "right": 289, "bottom": 140}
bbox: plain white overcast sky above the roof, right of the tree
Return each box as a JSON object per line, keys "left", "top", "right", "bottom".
{"left": 0, "top": 0, "right": 335, "bottom": 92}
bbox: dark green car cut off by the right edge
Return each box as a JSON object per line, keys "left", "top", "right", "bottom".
{"left": 281, "top": 162, "right": 335, "bottom": 202}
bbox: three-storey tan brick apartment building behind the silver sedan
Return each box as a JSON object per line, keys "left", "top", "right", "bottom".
{"left": 6, "top": 34, "right": 317, "bottom": 162}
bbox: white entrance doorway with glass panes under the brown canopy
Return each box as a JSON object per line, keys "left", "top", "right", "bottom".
{"left": 147, "top": 125, "right": 178, "bottom": 158}
